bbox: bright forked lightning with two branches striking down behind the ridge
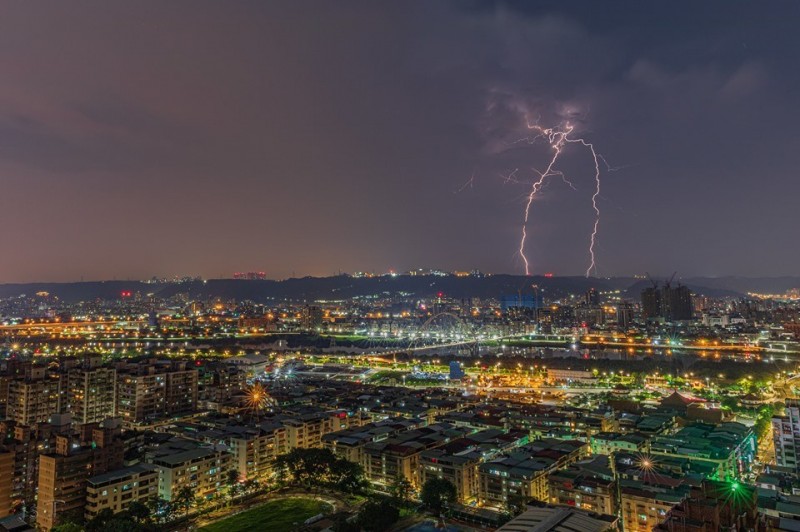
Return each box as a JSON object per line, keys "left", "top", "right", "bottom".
{"left": 519, "top": 122, "right": 608, "bottom": 277}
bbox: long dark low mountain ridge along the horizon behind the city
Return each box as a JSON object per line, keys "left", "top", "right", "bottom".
{"left": 0, "top": 274, "right": 800, "bottom": 303}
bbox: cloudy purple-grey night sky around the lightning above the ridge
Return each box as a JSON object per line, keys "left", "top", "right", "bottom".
{"left": 0, "top": 0, "right": 800, "bottom": 282}
